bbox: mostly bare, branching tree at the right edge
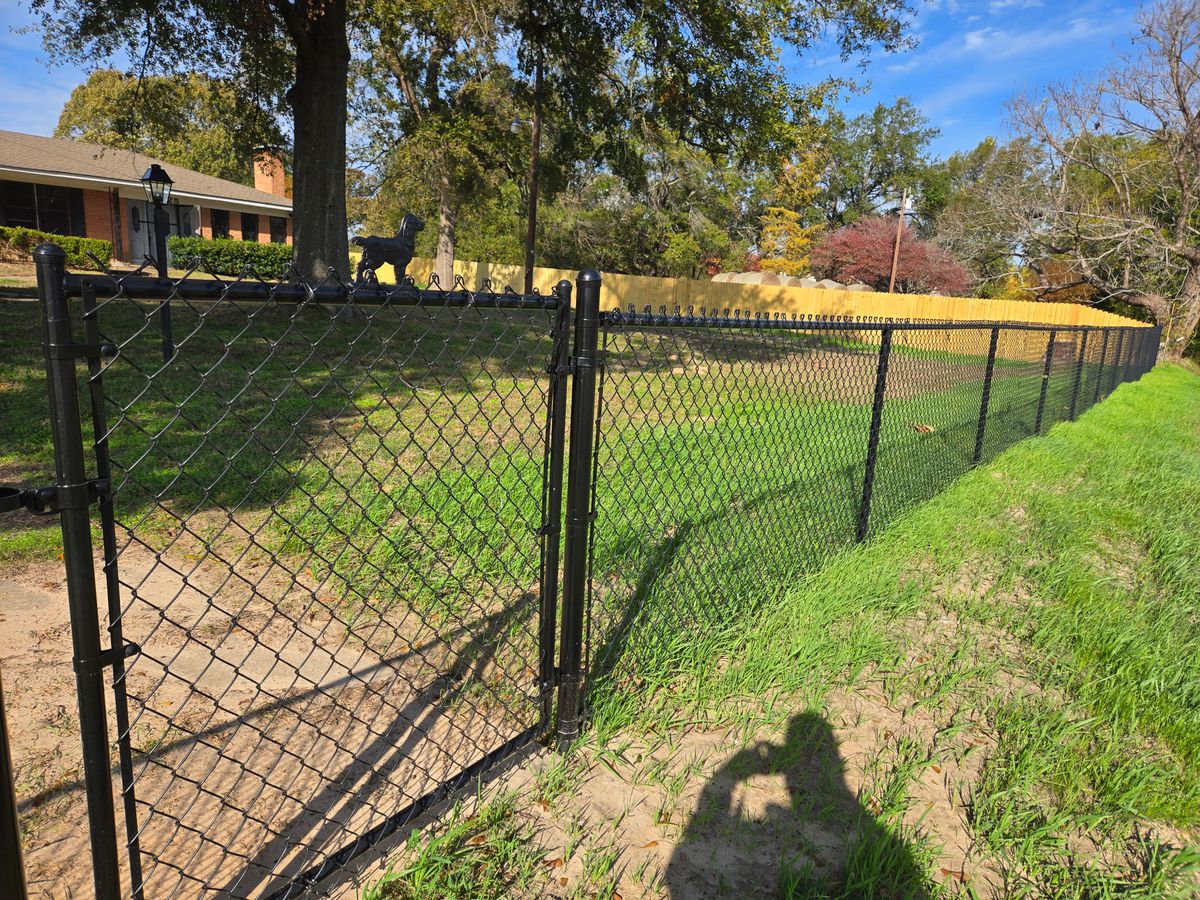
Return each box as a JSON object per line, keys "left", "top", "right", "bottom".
{"left": 1008, "top": 0, "right": 1200, "bottom": 355}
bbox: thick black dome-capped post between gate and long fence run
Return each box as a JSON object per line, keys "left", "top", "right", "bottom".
{"left": 558, "top": 269, "right": 601, "bottom": 749}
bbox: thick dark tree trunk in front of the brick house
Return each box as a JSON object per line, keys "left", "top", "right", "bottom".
{"left": 288, "top": 0, "right": 350, "bottom": 278}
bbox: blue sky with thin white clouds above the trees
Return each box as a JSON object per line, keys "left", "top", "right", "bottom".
{"left": 0, "top": 0, "right": 1136, "bottom": 156}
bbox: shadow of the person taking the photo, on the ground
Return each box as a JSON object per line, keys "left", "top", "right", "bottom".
{"left": 665, "top": 713, "right": 930, "bottom": 900}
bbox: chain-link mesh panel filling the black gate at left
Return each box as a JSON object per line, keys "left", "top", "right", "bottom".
{"left": 85, "top": 267, "right": 559, "bottom": 898}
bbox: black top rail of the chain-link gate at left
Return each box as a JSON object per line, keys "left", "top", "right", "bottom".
{"left": 64, "top": 272, "right": 563, "bottom": 310}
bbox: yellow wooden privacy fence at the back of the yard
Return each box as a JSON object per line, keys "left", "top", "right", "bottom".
{"left": 362, "top": 257, "right": 1147, "bottom": 333}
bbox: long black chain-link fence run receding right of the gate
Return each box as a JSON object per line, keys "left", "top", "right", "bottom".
{"left": 587, "top": 307, "right": 1158, "bottom": 680}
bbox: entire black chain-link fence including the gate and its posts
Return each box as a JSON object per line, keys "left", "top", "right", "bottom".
{"left": 0, "top": 255, "right": 1159, "bottom": 900}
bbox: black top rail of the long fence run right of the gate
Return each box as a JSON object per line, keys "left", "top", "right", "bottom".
{"left": 600, "top": 307, "right": 1152, "bottom": 334}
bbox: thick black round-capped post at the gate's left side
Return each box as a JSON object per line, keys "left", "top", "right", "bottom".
{"left": 34, "top": 244, "right": 120, "bottom": 900}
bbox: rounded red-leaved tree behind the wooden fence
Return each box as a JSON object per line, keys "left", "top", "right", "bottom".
{"left": 810, "top": 216, "right": 971, "bottom": 295}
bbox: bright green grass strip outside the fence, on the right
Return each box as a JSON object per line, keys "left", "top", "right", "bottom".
{"left": 578, "top": 366, "right": 1200, "bottom": 898}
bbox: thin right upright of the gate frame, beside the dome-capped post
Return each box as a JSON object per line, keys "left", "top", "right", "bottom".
{"left": 538, "top": 280, "right": 571, "bottom": 728}
